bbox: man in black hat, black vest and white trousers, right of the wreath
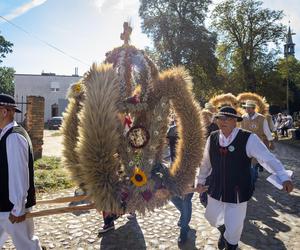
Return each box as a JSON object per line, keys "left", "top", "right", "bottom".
{"left": 197, "top": 107, "right": 293, "bottom": 249}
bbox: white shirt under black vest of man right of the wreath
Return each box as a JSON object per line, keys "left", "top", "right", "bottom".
{"left": 197, "top": 128, "right": 290, "bottom": 185}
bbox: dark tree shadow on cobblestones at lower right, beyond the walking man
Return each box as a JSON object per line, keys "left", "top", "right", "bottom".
{"left": 241, "top": 142, "right": 300, "bottom": 250}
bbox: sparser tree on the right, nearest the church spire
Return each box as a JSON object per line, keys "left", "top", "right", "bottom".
{"left": 212, "top": 0, "right": 286, "bottom": 91}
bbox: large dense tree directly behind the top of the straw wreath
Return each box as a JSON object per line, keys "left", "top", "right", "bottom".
{"left": 139, "top": 0, "right": 217, "bottom": 101}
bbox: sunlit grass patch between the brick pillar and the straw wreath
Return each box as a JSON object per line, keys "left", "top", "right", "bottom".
{"left": 34, "top": 156, "right": 74, "bottom": 192}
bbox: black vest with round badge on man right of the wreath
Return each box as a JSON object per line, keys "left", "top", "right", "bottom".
{"left": 208, "top": 130, "right": 254, "bottom": 203}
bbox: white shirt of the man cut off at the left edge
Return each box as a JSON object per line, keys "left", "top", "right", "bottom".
{"left": 0, "top": 121, "right": 29, "bottom": 216}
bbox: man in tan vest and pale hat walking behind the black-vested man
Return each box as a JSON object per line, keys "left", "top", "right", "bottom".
{"left": 241, "top": 100, "right": 274, "bottom": 182}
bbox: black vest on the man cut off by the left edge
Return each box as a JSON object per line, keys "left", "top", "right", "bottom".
{"left": 0, "top": 126, "right": 36, "bottom": 212}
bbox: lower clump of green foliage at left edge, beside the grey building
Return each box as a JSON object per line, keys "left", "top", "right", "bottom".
{"left": 0, "top": 67, "right": 15, "bottom": 96}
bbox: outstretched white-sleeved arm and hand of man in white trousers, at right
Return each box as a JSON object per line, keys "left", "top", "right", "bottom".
{"left": 246, "top": 134, "right": 293, "bottom": 192}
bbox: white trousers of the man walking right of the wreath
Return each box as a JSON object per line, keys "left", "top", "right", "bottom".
{"left": 205, "top": 196, "right": 247, "bottom": 245}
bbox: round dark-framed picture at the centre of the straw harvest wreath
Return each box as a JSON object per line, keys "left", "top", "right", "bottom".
{"left": 127, "top": 126, "right": 150, "bottom": 148}
